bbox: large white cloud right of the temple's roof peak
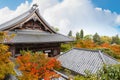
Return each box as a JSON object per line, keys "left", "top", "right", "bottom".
{"left": 44, "top": 0, "right": 118, "bottom": 35}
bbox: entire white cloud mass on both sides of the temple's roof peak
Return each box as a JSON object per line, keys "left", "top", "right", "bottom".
{"left": 0, "top": 0, "right": 120, "bottom": 36}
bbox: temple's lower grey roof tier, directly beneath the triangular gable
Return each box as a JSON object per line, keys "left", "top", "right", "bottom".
{"left": 6, "top": 30, "right": 73, "bottom": 43}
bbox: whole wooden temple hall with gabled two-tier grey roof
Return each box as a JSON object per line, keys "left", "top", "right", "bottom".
{"left": 0, "top": 5, "right": 73, "bottom": 57}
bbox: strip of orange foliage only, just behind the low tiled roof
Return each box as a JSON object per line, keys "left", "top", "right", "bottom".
{"left": 75, "top": 40, "right": 120, "bottom": 57}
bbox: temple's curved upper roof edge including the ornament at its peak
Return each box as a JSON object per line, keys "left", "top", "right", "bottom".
{"left": 0, "top": 4, "right": 57, "bottom": 33}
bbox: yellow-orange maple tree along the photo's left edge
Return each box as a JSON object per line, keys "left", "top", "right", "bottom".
{"left": 0, "top": 32, "right": 15, "bottom": 80}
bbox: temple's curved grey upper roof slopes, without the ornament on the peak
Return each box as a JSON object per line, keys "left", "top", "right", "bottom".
{"left": 0, "top": 5, "right": 55, "bottom": 33}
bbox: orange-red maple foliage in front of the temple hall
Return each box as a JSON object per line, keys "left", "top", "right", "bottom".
{"left": 17, "top": 53, "right": 60, "bottom": 80}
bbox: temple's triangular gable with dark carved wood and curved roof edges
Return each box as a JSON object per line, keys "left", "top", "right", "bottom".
{"left": 0, "top": 9, "right": 55, "bottom": 33}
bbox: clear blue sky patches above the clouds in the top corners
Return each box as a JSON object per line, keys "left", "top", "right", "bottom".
{"left": 0, "top": 0, "right": 120, "bottom": 13}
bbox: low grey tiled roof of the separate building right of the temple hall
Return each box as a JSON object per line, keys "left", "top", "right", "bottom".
{"left": 58, "top": 48, "right": 119, "bottom": 75}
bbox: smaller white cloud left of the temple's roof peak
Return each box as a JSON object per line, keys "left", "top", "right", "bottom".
{"left": 0, "top": 1, "right": 30, "bottom": 24}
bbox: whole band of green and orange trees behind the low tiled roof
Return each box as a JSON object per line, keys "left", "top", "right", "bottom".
{"left": 61, "top": 29, "right": 120, "bottom": 59}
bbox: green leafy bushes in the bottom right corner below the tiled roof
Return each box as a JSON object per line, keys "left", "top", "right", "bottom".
{"left": 74, "top": 64, "right": 120, "bottom": 80}
